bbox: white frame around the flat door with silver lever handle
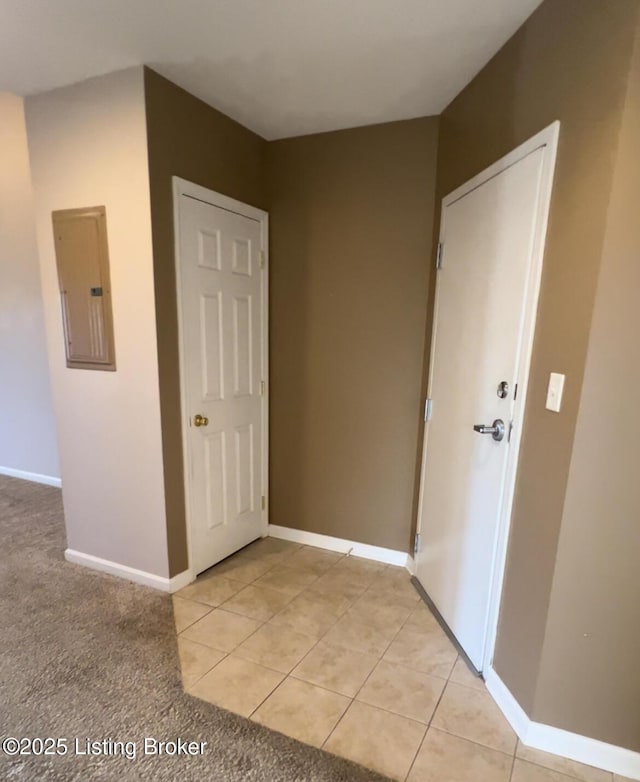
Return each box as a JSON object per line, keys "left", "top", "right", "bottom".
{"left": 416, "top": 120, "right": 560, "bottom": 674}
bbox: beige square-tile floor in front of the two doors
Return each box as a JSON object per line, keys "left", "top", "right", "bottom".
{"left": 173, "top": 538, "right": 623, "bottom": 782}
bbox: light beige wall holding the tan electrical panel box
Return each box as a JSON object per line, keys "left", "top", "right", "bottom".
{"left": 26, "top": 68, "right": 168, "bottom": 578}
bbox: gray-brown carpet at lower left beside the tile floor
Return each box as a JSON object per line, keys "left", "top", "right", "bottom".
{"left": 0, "top": 476, "right": 384, "bottom": 782}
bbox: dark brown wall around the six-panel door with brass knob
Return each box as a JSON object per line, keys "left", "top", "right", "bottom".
{"left": 144, "top": 68, "right": 266, "bottom": 576}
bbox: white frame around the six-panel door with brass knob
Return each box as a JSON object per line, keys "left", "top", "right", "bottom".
{"left": 172, "top": 176, "right": 269, "bottom": 581}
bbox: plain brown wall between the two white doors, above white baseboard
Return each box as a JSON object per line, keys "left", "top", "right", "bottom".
{"left": 267, "top": 117, "right": 438, "bottom": 551}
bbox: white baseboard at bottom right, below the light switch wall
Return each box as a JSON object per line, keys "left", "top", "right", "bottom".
{"left": 485, "top": 668, "right": 640, "bottom": 780}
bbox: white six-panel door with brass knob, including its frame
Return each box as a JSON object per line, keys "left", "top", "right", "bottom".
{"left": 175, "top": 180, "right": 267, "bottom": 575}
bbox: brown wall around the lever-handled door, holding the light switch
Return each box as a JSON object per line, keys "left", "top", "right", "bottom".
{"left": 438, "top": 0, "right": 638, "bottom": 729}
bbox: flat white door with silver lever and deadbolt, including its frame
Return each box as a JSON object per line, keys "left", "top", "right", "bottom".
{"left": 417, "top": 127, "right": 557, "bottom": 671}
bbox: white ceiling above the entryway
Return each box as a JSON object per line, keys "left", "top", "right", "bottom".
{"left": 0, "top": 0, "right": 541, "bottom": 139}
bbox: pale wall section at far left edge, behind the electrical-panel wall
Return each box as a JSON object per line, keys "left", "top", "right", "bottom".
{"left": 0, "top": 93, "right": 60, "bottom": 481}
